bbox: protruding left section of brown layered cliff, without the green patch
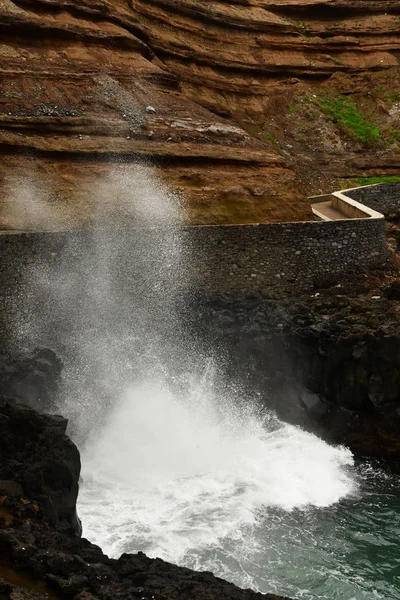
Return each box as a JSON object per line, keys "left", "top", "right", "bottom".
{"left": 0, "top": 0, "right": 311, "bottom": 228}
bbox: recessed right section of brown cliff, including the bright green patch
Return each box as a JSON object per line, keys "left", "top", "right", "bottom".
{"left": 128, "top": 0, "right": 400, "bottom": 192}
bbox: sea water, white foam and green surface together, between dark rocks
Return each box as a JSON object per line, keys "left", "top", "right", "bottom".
{"left": 78, "top": 381, "right": 400, "bottom": 600}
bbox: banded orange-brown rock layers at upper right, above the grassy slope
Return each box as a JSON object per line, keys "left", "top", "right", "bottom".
{"left": 128, "top": 0, "right": 400, "bottom": 120}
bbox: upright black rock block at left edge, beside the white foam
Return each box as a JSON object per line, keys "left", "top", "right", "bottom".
{"left": 0, "top": 397, "right": 81, "bottom": 535}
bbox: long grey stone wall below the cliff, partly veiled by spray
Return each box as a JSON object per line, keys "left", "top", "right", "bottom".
{"left": 0, "top": 219, "right": 387, "bottom": 297}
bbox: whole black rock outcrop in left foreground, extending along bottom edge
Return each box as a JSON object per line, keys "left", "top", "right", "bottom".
{"left": 0, "top": 398, "right": 294, "bottom": 600}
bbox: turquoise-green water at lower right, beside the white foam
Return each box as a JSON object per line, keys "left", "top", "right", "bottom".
{"left": 191, "top": 465, "right": 400, "bottom": 600}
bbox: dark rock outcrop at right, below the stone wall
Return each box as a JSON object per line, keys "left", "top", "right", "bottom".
{"left": 188, "top": 274, "right": 400, "bottom": 473}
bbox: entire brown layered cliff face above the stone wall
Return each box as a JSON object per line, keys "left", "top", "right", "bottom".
{"left": 0, "top": 0, "right": 400, "bottom": 228}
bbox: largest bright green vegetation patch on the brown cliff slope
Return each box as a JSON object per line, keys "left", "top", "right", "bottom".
{"left": 318, "top": 95, "right": 382, "bottom": 146}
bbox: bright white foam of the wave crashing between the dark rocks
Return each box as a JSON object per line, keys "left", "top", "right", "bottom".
{"left": 78, "top": 382, "right": 356, "bottom": 564}
